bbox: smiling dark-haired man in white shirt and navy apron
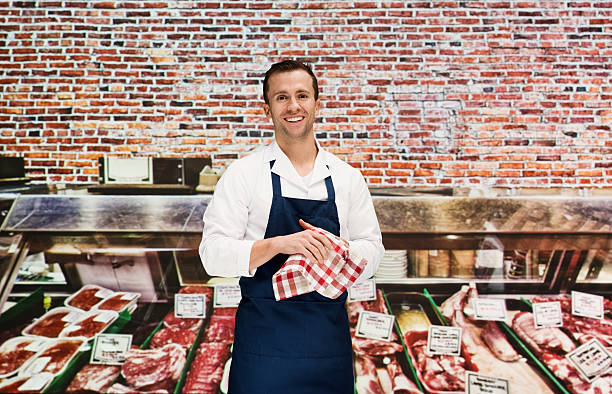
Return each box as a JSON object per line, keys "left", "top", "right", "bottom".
{"left": 200, "top": 60, "right": 384, "bottom": 394}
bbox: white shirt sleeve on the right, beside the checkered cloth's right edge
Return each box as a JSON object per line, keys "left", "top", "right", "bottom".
{"left": 347, "top": 173, "right": 385, "bottom": 283}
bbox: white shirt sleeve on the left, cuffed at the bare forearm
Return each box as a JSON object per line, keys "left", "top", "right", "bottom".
{"left": 199, "top": 162, "right": 254, "bottom": 277}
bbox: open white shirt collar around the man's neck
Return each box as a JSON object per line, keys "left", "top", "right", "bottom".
{"left": 265, "top": 140, "right": 331, "bottom": 184}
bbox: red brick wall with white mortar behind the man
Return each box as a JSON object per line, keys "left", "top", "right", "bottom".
{"left": 0, "top": 0, "right": 612, "bottom": 187}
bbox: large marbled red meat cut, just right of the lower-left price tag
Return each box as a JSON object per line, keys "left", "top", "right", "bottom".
{"left": 121, "top": 343, "right": 186, "bottom": 391}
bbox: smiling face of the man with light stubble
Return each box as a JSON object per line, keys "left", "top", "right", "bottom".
{"left": 264, "top": 70, "right": 320, "bottom": 142}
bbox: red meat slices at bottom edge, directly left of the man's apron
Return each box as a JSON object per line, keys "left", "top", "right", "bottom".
{"left": 183, "top": 342, "right": 231, "bottom": 394}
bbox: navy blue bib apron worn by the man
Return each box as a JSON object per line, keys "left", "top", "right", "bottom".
{"left": 229, "top": 161, "right": 354, "bottom": 394}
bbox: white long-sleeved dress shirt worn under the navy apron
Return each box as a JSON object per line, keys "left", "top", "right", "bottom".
{"left": 200, "top": 142, "right": 384, "bottom": 282}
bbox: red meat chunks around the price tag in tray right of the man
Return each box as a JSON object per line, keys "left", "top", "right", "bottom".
{"left": 404, "top": 331, "right": 478, "bottom": 393}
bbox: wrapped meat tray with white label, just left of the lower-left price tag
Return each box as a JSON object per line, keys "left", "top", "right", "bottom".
{"left": 18, "top": 338, "right": 86, "bottom": 376}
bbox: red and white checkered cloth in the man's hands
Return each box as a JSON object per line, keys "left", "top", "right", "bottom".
{"left": 272, "top": 228, "right": 368, "bottom": 301}
